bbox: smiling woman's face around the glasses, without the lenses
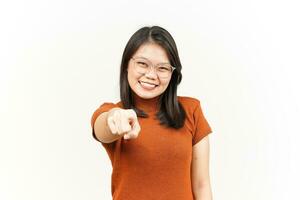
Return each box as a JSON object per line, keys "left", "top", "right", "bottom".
{"left": 127, "top": 43, "right": 172, "bottom": 99}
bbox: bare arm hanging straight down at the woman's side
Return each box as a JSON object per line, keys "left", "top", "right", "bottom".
{"left": 191, "top": 136, "right": 212, "bottom": 200}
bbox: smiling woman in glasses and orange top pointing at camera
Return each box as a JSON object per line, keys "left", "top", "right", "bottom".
{"left": 91, "top": 26, "right": 212, "bottom": 200}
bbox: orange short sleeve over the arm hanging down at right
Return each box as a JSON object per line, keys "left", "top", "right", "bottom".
{"left": 192, "top": 100, "right": 212, "bottom": 145}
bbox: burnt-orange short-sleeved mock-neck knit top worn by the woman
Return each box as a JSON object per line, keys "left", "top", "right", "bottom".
{"left": 91, "top": 96, "right": 212, "bottom": 200}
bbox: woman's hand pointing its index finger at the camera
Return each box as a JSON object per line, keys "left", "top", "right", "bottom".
{"left": 107, "top": 108, "right": 141, "bottom": 139}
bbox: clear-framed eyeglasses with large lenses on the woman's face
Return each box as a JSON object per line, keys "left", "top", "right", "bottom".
{"left": 131, "top": 57, "right": 175, "bottom": 78}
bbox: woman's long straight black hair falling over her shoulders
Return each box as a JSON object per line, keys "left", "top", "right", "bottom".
{"left": 120, "top": 26, "right": 186, "bottom": 129}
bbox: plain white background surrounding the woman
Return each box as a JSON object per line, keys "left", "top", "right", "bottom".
{"left": 0, "top": 0, "right": 300, "bottom": 200}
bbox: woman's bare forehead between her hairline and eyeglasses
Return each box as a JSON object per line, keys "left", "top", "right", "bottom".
{"left": 133, "top": 43, "right": 169, "bottom": 63}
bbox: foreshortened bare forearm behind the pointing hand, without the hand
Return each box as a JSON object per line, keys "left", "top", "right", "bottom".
{"left": 94, "top": 108, "right": 123, "bottom": 143}
